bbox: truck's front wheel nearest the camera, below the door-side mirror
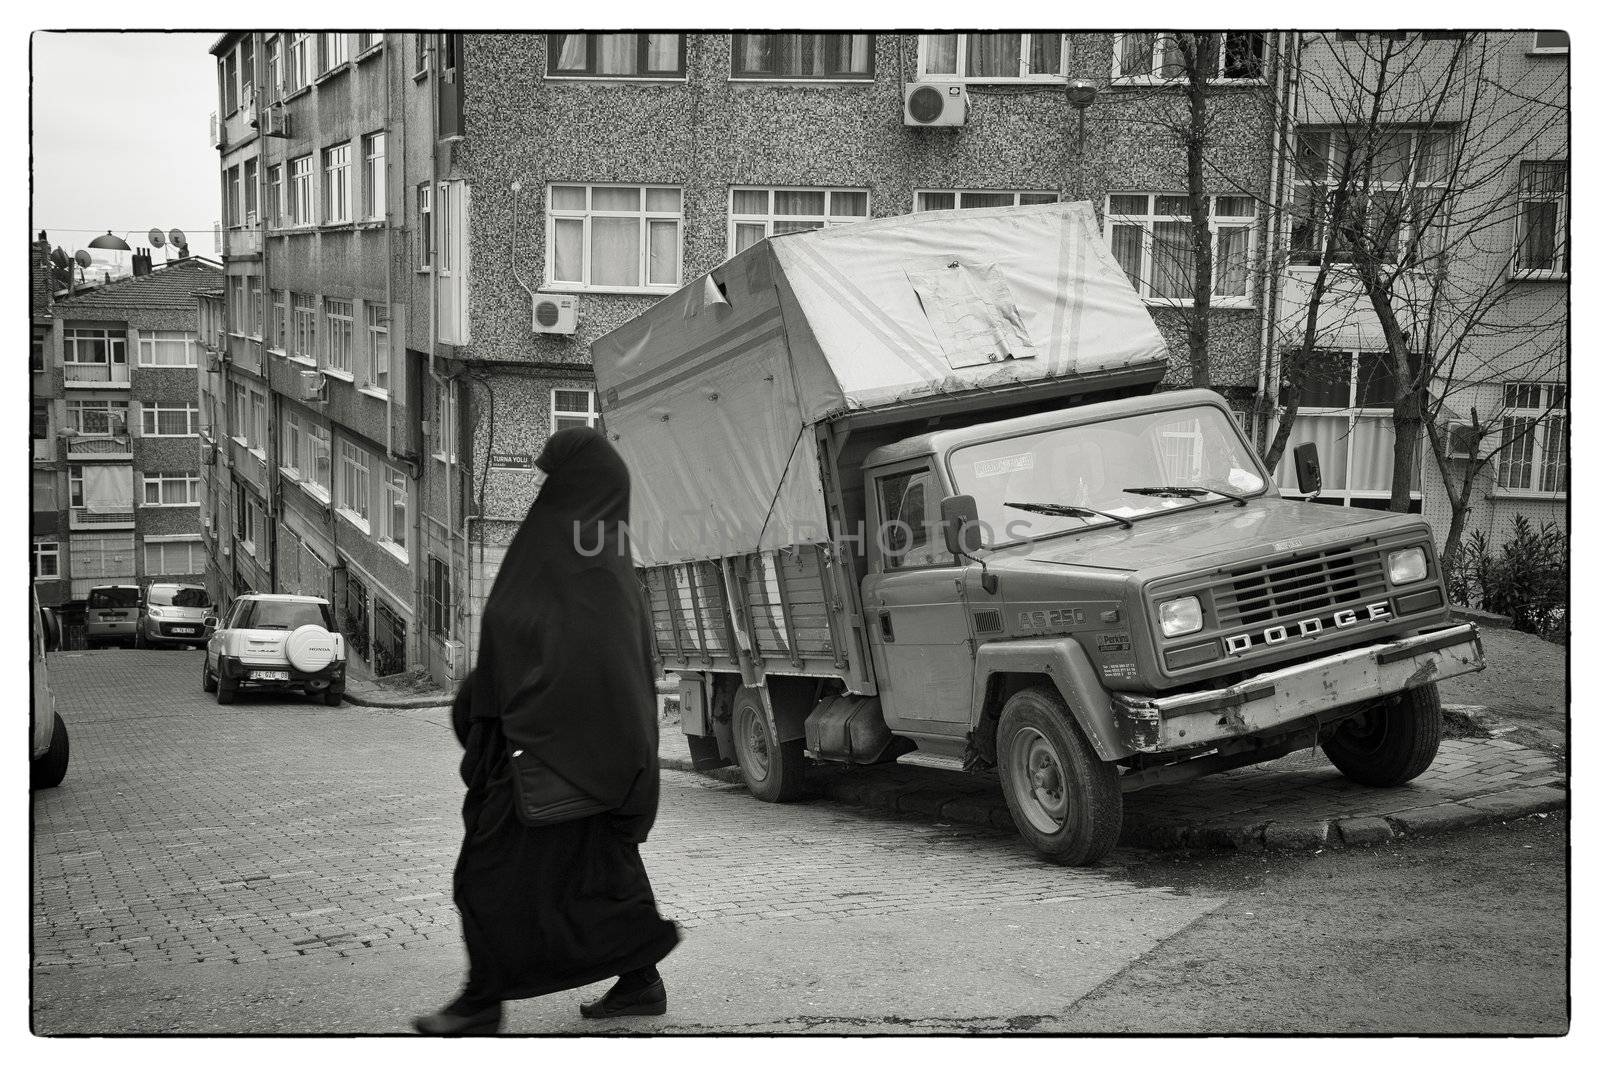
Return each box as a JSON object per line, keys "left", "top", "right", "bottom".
{"left": 995, "top": 686, "right": 1122, "bottom": 867}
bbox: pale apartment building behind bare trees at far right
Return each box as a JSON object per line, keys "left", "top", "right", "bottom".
{"left": 1264, "top": 30, "right": 1570, "bottom": 544}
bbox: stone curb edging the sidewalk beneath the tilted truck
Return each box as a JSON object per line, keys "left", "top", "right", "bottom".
{"left": 661, "top": 757, "right": 1566, "bottom": 853}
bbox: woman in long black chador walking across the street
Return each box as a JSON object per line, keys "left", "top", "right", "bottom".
{"left": 416, "top": 429, "right": 678, "bottom": 1033}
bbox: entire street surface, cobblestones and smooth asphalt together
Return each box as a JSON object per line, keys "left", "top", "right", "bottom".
{"left": 32, "top": 651, "right": 1566, "bottom": 1033}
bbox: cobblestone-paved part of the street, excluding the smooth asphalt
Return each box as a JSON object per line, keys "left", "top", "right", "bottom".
{"left": 32, "top": 651, "right": 1203, "bottom": 973}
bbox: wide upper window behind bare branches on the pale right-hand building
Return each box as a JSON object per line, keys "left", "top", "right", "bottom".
{"left": 1290, "top": 126, "right": 1453, "bottom": 266}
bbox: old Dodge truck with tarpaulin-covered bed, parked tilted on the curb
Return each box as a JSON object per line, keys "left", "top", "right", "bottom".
{"left": 592, "top": 203, "right": 1483, "bottom": 864}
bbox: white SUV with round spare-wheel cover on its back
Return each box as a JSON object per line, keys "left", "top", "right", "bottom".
{"left": 200, "top": 593, "right": 344, "bottom": 707}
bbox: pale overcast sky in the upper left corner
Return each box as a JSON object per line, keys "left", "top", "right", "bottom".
{"left": 32, "top": 32, "right": 221, "bottom": 264}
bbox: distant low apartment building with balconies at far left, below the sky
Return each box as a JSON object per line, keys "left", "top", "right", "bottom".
{"left": 30, "top": 240, "right": 221, "bottom": 606}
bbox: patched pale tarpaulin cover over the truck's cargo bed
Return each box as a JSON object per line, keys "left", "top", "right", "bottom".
{"left": 592, "top": 203, "right": 1166, "bottom": 566}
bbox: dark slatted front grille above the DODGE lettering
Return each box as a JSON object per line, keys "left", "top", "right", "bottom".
{"left": 1213, "top": 545, "right": 1387, "bottom": 629}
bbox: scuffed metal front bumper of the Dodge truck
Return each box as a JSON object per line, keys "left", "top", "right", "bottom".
{"left": 1112, "top": 622, "right": 1483, "bottom": 752}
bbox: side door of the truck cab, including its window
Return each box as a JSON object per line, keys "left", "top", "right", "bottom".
{"left": 861, "top": 461, "right": 973, "bottom": 737}
